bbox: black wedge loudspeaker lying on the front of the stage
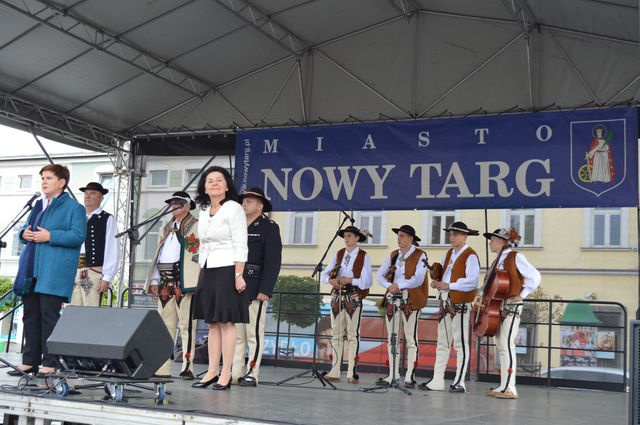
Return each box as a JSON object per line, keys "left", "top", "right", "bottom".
{"left": 47, "top": 306, "right": 173, "bottom": 379}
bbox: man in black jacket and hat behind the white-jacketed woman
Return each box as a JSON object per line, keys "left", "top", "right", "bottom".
{"left": 231, "top": 187, "right": 282, "bottom": 387}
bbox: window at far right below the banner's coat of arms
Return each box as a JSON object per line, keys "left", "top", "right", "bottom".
{"left": 585, "top": 208, "right": 629, "bottom": 248}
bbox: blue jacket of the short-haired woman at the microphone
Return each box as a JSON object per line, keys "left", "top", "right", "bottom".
{"left": 20, "top": 192, "right": 87, "bottom": 302}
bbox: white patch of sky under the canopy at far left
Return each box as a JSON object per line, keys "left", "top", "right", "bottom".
{"left": 0, "top": 125, "right": 89, "bottom": 158}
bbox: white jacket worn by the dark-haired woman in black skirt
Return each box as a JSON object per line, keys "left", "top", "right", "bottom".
{"left": 198, "top": 200, "right": 249, "bottom": 268}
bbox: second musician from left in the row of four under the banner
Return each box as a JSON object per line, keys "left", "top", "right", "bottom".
{"left": 376, "top": 224, "right": 429, "bottom": 388}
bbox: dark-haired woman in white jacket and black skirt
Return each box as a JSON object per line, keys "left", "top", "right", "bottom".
{"left": 192, "top": 166, "right": 249, "bottom": 390}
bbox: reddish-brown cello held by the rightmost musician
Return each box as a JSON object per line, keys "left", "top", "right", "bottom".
{"left": 473, "top": 229, "right": 520, "bottom": 336}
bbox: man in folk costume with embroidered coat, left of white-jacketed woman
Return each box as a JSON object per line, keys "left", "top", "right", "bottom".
{"left": 144, "top": 191, "right": 200, "bottom": 380}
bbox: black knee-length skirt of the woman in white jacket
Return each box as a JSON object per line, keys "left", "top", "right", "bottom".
{"left": 191, "top": 266, "right": 249, "bottom": 323}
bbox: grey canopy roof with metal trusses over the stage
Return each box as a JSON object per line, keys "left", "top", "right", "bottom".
{"left": 0, "top": 0, "right": 640, "bottom": 149}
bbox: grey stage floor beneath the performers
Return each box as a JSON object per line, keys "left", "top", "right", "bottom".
{"left": 0, "top": 355, "right": 628, "bottom": 425}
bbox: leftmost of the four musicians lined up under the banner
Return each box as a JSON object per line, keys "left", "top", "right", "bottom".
{"left": 320, "top": 226, "right": 372, "bottom": 384}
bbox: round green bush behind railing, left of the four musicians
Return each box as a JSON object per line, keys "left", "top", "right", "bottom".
{"left": 269, "top": 276, "right": 323, "bottom": 328}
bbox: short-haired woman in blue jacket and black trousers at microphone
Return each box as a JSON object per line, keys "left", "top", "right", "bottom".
{"left": 8, "top": 164, "right": 87, "bottom": 375}
